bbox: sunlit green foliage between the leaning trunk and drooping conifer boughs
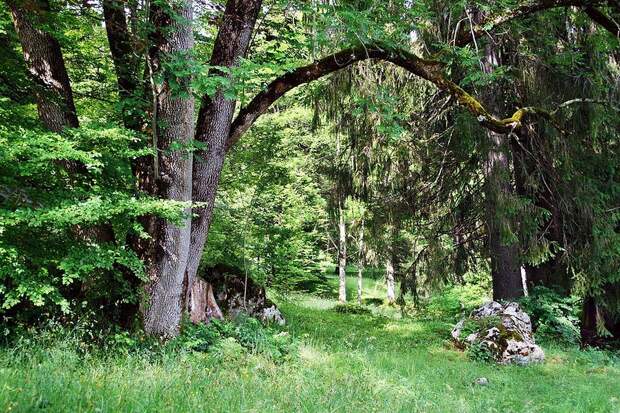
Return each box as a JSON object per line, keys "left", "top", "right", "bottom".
{"left": 203, "top": 107, "right": 330, "bottom": 291}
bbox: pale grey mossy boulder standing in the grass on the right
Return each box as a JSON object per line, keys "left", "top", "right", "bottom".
{"left": 452, "top": 301, "right": 545, "bottom": 364}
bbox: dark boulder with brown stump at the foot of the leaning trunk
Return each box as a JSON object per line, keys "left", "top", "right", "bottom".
{"left": 188, "top": 264, "right": 286, "bottom": 325}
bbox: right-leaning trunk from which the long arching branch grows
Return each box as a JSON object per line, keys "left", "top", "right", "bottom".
{"left": 186, "top": 0, "right": 262, "bottom": 298}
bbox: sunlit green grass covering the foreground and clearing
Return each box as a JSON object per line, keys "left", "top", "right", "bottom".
{"left": 0, "top": 280, "right": 620, "bottom": 412}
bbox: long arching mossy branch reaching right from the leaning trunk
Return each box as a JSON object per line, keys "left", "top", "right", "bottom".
{"left": 226, "top": 44, "right": 542, "bottom": 150}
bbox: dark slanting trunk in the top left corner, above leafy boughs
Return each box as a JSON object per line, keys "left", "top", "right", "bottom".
{"left": 7, "top": 0, "right": 79, "bottom": 132}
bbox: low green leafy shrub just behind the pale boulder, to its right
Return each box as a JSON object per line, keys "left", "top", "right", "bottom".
{"left": 521, "top": 287, "right": 581, "bottom": 344}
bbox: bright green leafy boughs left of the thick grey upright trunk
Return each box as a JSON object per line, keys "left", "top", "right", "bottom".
{"left": 0, "top": 108, "right": 183, "bottom": 319}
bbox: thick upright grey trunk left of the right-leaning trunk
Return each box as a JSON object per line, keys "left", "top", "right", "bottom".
{"left": 144, "top": 0, "right": 194, "bottom": 337}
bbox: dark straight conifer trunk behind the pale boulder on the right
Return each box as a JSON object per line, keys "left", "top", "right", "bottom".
{"left": 482, "top": 33, "right": 523, "bottom": 300}
